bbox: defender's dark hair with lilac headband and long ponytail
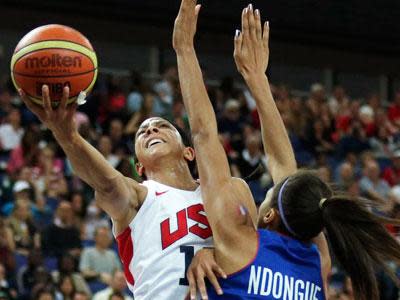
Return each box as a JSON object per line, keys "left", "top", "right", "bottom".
{"left": 272, "top": 171, "right": 400, "bottom": 300}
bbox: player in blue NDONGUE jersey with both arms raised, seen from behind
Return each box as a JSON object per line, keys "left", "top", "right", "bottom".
{"left": 173, "top": 0, "right": 400, "bottom": 300}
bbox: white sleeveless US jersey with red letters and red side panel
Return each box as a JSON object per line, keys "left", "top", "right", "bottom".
{"left": 112, "top": 180, "right": 212, "bottom": 300}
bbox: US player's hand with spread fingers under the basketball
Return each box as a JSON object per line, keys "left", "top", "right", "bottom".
{"left": 18, "top": 85, "right": 77, "bottom": 137}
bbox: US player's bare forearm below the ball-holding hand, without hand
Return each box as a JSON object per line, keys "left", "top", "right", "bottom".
{"left": 54, "top": 132, "right": 120, "bottom": 193}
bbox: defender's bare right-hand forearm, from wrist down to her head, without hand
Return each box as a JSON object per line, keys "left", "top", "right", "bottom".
{"left": 244, "top": 74, "right": 297, "bottom": 183}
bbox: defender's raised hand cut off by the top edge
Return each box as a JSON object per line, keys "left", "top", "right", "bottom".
{"left": 172, "top": 0, "right": 201, "bottom": 52}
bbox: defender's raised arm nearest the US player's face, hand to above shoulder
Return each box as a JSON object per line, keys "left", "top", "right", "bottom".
{"left": 173, "top": 0, "right": 231, "bottom": 186}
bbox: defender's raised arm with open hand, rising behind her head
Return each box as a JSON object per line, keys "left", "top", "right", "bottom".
{"left": 234, "top": 5, "right": 297, "bottom": 183}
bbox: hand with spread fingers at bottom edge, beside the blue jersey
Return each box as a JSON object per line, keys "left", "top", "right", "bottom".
{"left": 187, "top": 248, "right": 226, "bottom": 300}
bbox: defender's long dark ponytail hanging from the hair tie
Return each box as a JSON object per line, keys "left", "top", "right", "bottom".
{"left": 321, "top": 195, "right": 400, "bottom": 300}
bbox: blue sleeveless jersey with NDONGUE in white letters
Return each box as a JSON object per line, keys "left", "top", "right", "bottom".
{"left": 207, "top": 229, "right": 325, "bottom": 300}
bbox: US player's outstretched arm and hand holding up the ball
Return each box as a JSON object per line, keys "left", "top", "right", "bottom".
{"left": 19, "top": 86, "right": 145, "bottom": 227}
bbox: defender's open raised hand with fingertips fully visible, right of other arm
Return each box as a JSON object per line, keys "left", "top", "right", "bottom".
{"left": 233, "top": 4, "right": 269, "bottom": 78}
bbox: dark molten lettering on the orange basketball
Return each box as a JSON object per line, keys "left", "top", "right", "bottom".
{"left": 25, "top": 54, "right": 82, "bottom": 69}
